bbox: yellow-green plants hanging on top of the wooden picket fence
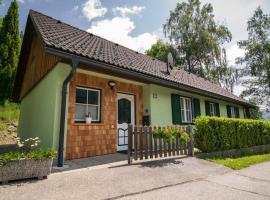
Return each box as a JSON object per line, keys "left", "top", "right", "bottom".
{"left": 153, "top": 127, "right": 190, "bottom": 144}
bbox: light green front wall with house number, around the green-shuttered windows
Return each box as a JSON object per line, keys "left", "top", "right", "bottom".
{"left": 143, "top": 84, "right": 244, "bottom": 126}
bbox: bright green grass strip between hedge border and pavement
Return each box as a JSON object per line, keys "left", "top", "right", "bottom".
{"left": 206, "top": 152, "right": 270, "bottom": 170}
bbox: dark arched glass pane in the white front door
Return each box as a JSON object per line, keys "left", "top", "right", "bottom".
{"left": 118, "top": 99, "right": 131, "bottom": 124}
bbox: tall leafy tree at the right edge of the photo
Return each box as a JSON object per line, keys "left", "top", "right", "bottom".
{"left": 237, "top": 7, "right": 270, "bottom": 107}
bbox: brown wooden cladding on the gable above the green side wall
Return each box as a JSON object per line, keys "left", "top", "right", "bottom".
{"left": 20, "top": 33, "right": 60, "bottom": 99}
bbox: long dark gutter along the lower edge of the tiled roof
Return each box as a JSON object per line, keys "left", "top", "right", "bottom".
{"left": 45, "top": 46, "right": 253, "bottom": 107}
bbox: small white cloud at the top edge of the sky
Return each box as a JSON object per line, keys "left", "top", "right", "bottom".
{"left": 82, "top": 0, "right": 107, "bottom": 21}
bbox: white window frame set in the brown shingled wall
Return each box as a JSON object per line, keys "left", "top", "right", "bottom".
{"left": 75, "top": 87, "right": 101, "bottom": 122}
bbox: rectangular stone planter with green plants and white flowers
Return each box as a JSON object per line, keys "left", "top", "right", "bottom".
{"left": 0, "top": 138, "right": 56, "bottom": 183}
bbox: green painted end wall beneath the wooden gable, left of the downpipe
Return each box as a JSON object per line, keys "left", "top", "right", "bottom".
{"left": 18, "top": 63, "right": 70, "bottom": 149}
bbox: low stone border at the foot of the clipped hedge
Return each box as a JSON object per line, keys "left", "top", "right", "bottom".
{"left": 195, "top": 144, "right": 270, "bottom": 159}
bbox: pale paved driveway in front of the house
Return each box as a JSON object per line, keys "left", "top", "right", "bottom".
{"left": 0, "top": 158, "right": 270, "bottom": 200}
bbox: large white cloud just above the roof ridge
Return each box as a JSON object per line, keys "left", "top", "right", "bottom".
{"left": 87, "top": 17, "right": 157, "bottom": 53}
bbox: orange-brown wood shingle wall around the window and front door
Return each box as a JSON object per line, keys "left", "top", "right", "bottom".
{"left": 66, "top": 73, "right": 143, "bottom": 160}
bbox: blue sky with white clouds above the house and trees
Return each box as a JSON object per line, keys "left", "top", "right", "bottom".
{"left": 0, "top": 0, "right": 270, "bottom": 95}
